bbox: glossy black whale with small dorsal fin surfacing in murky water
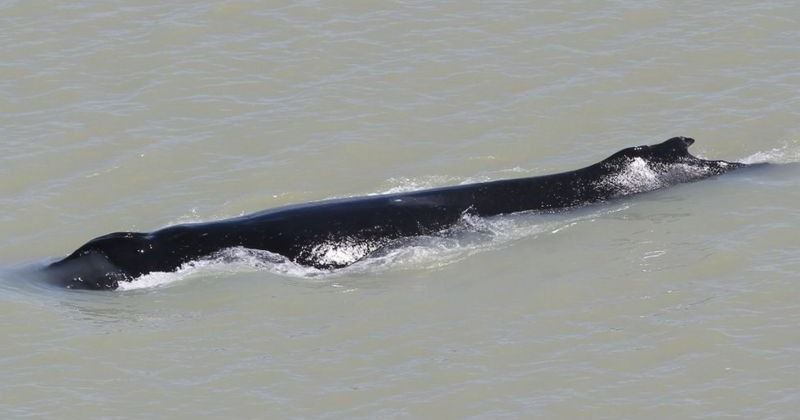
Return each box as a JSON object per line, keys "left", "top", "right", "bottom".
{"left": 44, "top": 137, "right": 748, "bottom": 290}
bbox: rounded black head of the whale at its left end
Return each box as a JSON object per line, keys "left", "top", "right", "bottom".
{"left": 45, "top": 232, "right": 158, "bottom": 289}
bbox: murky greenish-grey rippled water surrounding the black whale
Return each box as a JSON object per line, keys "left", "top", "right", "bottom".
{"left": 0, "top": 0, "right": 800, "bottom": 418}
